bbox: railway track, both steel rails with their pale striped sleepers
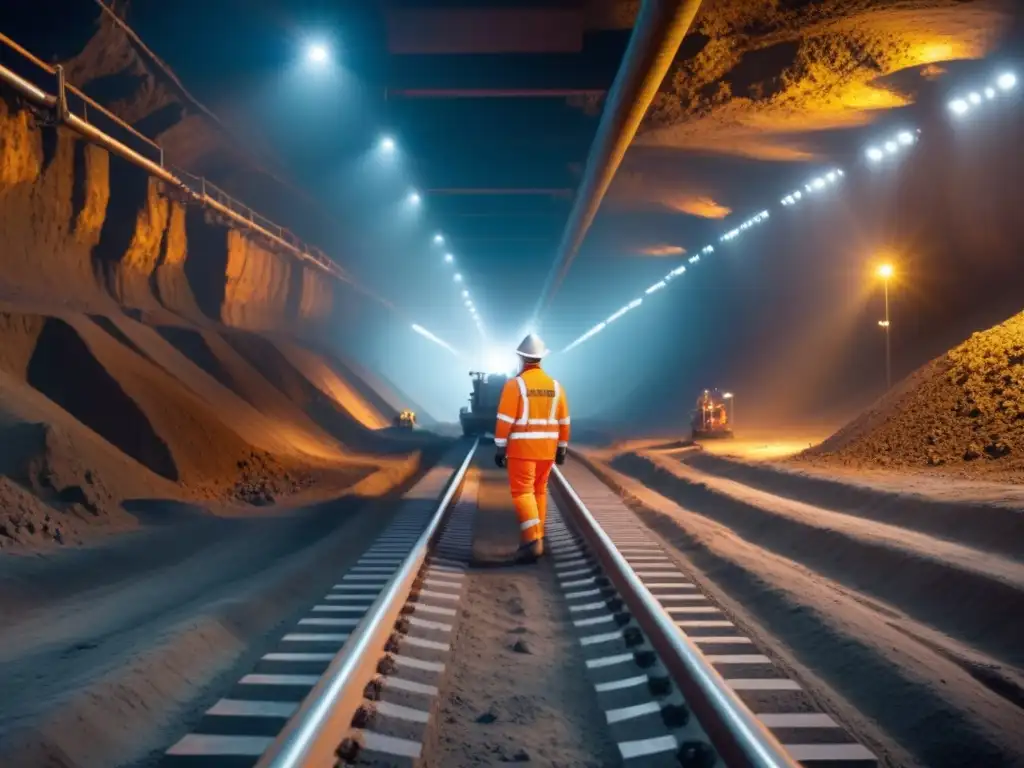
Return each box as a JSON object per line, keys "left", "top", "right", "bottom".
{"left": 160, "top": 442, "right": 877, "bottom": 768}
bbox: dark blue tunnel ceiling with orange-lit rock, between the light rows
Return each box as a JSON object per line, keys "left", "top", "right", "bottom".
{"left": 70, "top": 0, "right": 1020, "bottom": 354}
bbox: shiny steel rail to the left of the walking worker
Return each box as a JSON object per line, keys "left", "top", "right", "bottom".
{"left": 256, "top": 438, "right": 480, "bottom": 768}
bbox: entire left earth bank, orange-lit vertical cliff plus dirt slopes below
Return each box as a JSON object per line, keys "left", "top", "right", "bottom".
{"left": 0, "top": 78, "right": 436, "bottom": 551}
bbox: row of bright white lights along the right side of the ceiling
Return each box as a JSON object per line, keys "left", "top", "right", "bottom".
{"left": 562, "top": 64, "right": 1017, "bottom": 352}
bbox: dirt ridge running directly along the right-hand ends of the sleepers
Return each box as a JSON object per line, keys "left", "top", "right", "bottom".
{"left": 595, "top": 456, "right": 1024, "bottom": 768}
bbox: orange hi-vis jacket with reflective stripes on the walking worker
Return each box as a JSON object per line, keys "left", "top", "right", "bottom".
{"left": 495, "top": 365, "right": 569, "bottom": 461}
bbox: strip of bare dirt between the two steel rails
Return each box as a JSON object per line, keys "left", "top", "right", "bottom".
{"left": 423, "top": 470, "right": 621, "bottom": 768}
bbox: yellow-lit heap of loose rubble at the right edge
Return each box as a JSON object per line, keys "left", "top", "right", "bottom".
{"left": 797, "top": 312, "right": 1024, "bottom": 482}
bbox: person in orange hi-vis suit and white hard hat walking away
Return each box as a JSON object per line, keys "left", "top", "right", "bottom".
{"left": 495, "top": 334, "right": 569, "bottom": 561}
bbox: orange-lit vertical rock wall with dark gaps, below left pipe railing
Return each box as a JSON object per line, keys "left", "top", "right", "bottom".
{"left": 0, "top": 91, "right": 339, "bottom": 336}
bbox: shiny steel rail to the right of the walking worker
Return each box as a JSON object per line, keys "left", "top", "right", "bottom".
{"left": 552, "top": 467, "right": 798, "bottom": 768}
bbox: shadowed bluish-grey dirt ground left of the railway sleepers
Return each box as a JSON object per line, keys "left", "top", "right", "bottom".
{"left": 0, "top": 477, "right": 428, "bottom": 768}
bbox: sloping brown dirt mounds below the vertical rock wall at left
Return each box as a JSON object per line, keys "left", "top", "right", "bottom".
{"left": 0, "top": 312, "right": 389, "bottom": 544}
